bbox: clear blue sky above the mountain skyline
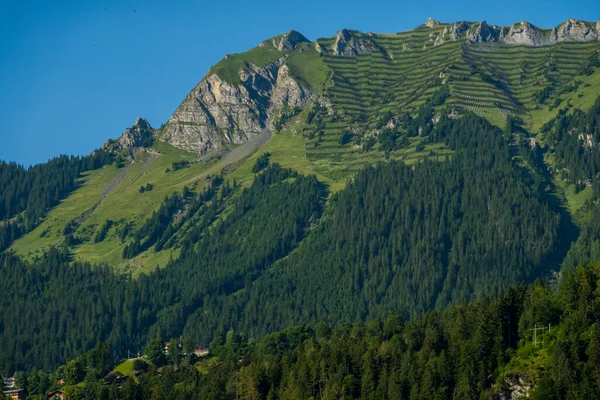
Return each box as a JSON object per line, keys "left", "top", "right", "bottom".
{"left": 0, "top": 0, "right": 600, "bottom": 165}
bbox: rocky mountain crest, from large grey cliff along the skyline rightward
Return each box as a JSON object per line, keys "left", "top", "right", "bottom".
{"left": 105, "top": 18, "right": 600, "bottom": 159}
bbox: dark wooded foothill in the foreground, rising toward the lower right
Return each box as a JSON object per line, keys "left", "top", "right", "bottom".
{"left": 10, "top": 265, "right": 600, "bottom": 400}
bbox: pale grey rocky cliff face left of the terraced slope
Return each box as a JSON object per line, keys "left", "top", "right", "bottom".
{"left": 161, "top": 55, "right": 314, "bottom": 154}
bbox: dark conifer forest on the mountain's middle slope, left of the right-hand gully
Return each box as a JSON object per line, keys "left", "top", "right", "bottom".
{"left": 0, "top": 114, "right": 562, "bottom": 371}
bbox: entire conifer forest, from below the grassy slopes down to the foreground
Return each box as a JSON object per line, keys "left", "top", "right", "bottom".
{"left": 0, "top": 74, "right": 600, "bottom": 399}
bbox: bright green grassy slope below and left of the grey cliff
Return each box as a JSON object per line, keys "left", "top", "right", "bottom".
{"left": 12, "top": 142, "right": 218, "bottom": 272}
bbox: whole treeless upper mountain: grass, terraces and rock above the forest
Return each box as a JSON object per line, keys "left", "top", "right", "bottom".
{"left": 4, "top": 20, "right": 600, "bottom": 274}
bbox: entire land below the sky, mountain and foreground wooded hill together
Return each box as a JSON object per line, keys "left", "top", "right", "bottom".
{"left": 0, "top": 14, "right": 600, "bottom": 400}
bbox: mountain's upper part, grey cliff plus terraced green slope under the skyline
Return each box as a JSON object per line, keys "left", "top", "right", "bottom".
{"left": 132, "top": 19, "right": 600, "bottom": 154}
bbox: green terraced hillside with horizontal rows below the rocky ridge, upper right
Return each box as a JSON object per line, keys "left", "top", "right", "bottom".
{"left": 317, "top": 23, "right": 600, "bottom": 128}
